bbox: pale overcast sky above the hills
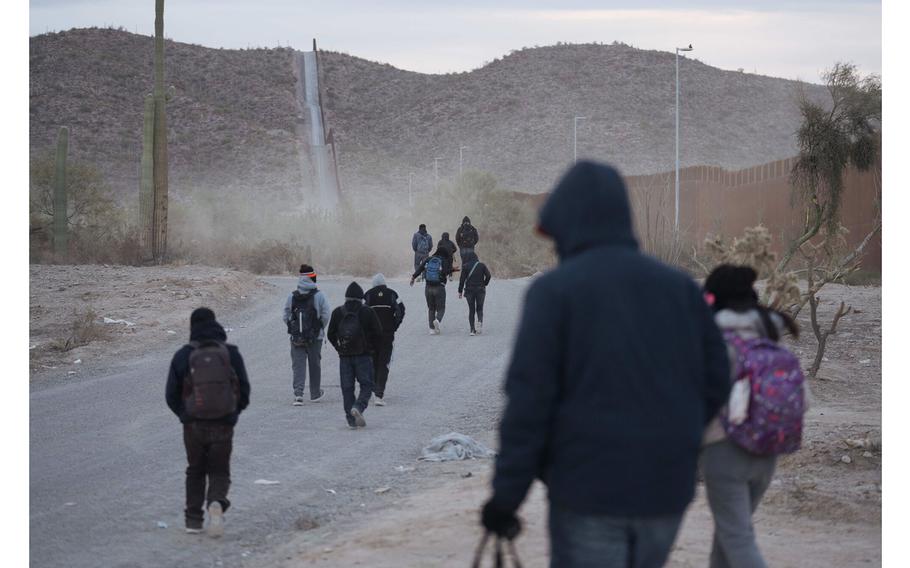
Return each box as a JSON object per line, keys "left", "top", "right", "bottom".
{"left": 29, "top": 0, "right": 882, "bottom": 82}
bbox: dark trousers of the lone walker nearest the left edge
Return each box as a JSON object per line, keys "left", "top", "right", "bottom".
{"left": 183, "top": 422, "right": 234, "bottom": 528}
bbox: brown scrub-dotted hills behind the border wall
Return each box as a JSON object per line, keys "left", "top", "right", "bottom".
{"left": 29, "top": 29, "right": 824, "bottom": 203}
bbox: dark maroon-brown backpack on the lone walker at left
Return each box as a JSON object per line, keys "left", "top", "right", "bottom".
{"left": 183, "top": 340, "right": 240, "bottom": 420}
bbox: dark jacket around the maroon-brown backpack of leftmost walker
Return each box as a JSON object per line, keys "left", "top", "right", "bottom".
{"left": 164, "top": 321, "right": 250, "bottom": 426}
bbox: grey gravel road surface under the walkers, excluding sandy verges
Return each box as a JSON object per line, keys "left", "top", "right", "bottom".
{"left": 29, "top": 277, "right": 527, "bottom": 568}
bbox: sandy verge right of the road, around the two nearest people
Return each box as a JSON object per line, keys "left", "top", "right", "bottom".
{"left": 255, "top": 285, "right": 882, "bottom": 568}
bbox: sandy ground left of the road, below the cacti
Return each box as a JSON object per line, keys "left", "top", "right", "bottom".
{"left": 29, "top": 264, "right": 268, "bottom": 380}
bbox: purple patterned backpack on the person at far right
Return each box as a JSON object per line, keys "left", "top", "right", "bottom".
{"left": 720, "top": 332, "right": 806, "bottom": 456}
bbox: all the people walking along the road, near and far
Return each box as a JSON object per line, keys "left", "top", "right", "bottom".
{"left": 166, "top": 162, "right": 808, "bottom": 568}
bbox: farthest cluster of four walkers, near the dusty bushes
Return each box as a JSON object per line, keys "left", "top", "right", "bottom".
{"left": 411, "top": 216, "right": 492, "bottom": 336}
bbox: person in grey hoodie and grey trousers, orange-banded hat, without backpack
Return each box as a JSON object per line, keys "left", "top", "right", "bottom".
{"left": 284, "top": 264, "right": 332, "bottom": 406}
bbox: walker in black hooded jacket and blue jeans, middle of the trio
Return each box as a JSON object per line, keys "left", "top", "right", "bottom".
{"left": 327, "top": 282, "right": 382, "bottom": 428}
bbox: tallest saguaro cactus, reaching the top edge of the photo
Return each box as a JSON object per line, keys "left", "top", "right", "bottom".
{"left": 153, "top": 0, "right": 168, "bottom": 262}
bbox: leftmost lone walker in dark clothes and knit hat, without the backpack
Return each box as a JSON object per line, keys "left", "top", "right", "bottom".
{"left": 165, "top": 308, "right": 250, "bottom": 537}
